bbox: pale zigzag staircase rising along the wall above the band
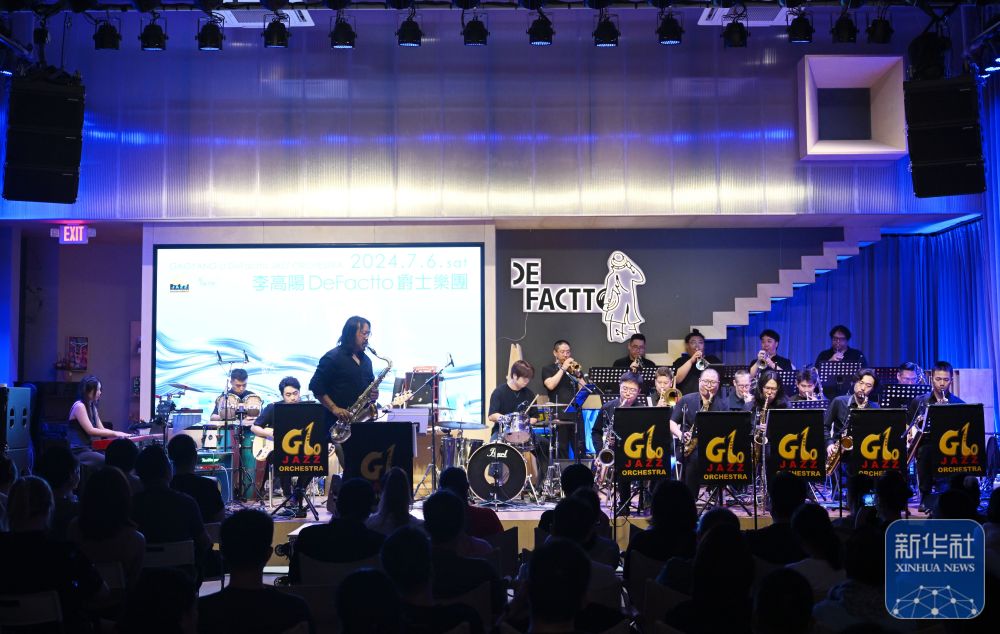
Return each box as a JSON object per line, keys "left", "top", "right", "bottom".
{"left": 667, "top": 226, "right": 881, "bottom": 360}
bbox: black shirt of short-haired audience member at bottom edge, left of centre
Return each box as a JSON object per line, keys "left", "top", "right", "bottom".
{"left": 198, "top": 588, "right": 314, "bottom": 634}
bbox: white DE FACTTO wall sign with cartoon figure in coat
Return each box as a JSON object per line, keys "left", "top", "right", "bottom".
{"left": 510, "top": 251, "right": 646, "bottom": 343}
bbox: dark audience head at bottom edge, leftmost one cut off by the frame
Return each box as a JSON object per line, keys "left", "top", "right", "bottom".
{"left": 118, "top": 568, "right": 198, "bottom": 634}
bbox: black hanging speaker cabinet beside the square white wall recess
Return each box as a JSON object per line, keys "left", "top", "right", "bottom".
{"left": 903, "top": 76, "right": 986, "bottom": 198}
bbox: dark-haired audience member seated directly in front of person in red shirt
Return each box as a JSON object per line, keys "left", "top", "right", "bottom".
{"left": 424, "top": 491, "right": 507, "bottom": 615}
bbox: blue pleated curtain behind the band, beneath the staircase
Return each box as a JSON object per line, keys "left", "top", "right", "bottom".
{"left": 721, "top": 221, "right": 998, "bottom": 368}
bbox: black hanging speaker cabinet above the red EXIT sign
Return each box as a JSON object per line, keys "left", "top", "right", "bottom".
{"left": 3, "top": 77, "right": 84, "bottom": 203}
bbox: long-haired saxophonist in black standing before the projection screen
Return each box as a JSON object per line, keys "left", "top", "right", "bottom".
{"left": 309, "top": 315, "right": 375, "bottom": 422}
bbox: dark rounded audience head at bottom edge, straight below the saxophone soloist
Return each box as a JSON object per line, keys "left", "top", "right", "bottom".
{"left": 336, "top": 564, "right": 403, "bottom": 634}
